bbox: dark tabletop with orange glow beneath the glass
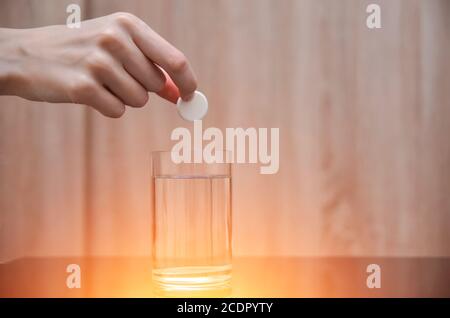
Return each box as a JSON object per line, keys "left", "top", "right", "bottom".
{"left": 0, "top": 257, "right": 450, "bottom": 297}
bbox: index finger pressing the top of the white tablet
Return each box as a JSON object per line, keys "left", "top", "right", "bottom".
{"left": 123, "top": 14, "right": 197, "bottom": 100}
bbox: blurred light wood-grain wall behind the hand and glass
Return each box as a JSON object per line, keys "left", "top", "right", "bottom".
{"left": 0, "top": 0, "right": 450, "bottom": 261}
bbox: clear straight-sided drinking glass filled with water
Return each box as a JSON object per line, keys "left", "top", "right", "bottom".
{"left": 152, "top": 152, "right": 232, "bottom": 296}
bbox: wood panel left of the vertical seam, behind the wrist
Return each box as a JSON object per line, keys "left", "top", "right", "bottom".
{"left": 0, "top": 0, "right": 86, "bottom": 261}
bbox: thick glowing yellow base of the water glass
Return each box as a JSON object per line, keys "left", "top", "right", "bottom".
{"left": 152, "top": 265, "right": 231, "bottom": 297}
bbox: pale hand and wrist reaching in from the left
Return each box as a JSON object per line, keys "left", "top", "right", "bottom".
{"left": 0, "top": 13, "right": 197, "bottom": 118}
